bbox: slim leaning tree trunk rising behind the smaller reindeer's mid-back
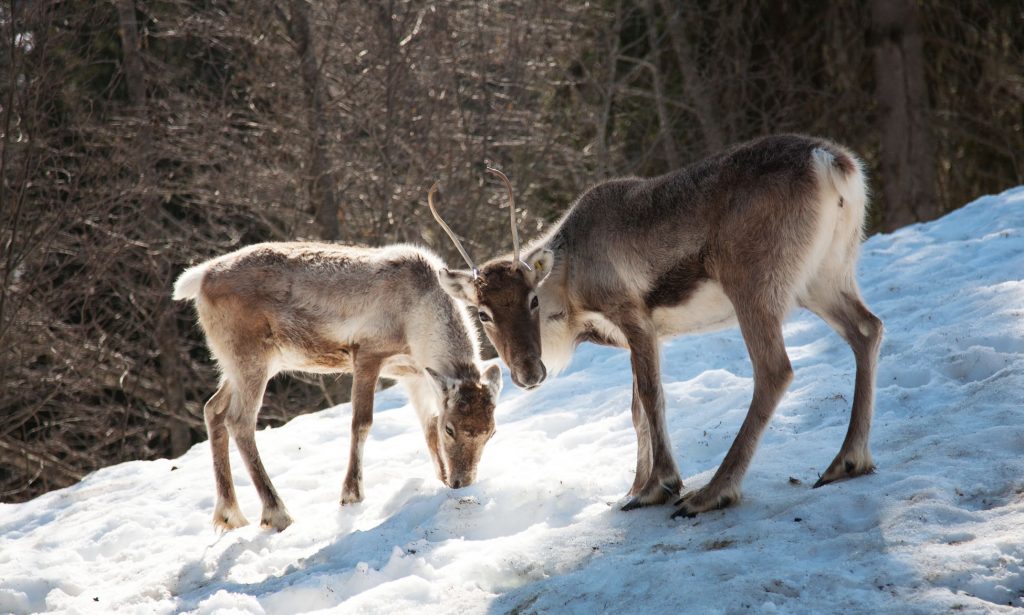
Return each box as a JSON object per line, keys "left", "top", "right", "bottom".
{"left": 278, "top": 0, "right": 341, "bottom": 239}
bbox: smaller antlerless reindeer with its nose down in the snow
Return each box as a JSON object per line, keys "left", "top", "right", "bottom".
{"left": 174, "top": 243, "right": 502, "bottom": 531}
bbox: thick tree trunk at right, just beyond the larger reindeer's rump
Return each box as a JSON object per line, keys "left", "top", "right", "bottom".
{"left": 871, "top": 0, "right": 940, "bottom": 230}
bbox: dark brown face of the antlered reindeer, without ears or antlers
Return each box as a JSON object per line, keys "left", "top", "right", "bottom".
{"left": 474, "top": 261, "right": 547, "bottom": 389}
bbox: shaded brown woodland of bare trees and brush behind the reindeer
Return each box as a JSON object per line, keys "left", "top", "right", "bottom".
{"left": 0, "top": 0, "right": 1024, "bottom": 501}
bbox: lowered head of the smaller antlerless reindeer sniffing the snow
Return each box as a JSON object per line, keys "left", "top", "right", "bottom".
{"left": 426, "top": 365, "right": 502, "bottom": 489}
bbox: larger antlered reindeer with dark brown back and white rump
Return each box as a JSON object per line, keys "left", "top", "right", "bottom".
{"left": 431, "top": 135, "right": 883, "bottom": 517}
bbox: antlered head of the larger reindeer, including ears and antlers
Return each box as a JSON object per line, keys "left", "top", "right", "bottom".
{"left": 427, "top": 168, "right": 554, "bottom": 389}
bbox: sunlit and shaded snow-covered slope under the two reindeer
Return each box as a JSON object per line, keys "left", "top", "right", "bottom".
{"left": 6, "top": 187, "right": 1024, "bottom": 614}
